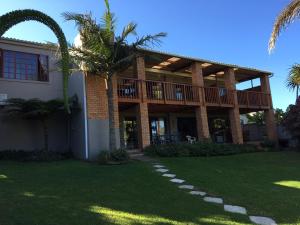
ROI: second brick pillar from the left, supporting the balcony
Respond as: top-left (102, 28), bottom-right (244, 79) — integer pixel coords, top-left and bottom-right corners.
top-left (192, 62), bottom-right (209, 140)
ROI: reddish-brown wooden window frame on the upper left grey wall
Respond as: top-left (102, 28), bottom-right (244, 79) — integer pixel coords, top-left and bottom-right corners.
top-left (0, 48), bottom-right (50, 83)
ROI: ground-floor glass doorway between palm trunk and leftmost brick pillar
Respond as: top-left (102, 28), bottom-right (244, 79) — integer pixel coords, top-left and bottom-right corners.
top-left (123, 118), bottom-right (138, 149)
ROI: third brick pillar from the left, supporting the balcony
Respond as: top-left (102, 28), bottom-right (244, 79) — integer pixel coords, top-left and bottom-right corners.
top-left (224, 68), bottom-right (243, 144)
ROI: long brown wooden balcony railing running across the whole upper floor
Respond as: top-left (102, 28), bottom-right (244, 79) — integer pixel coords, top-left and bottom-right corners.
top-left (118, 78), bottom-right (269, 108)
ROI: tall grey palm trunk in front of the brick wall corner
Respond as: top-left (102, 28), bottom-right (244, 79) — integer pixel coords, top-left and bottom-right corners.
top-left (107, 75), bottom-right (117, 151)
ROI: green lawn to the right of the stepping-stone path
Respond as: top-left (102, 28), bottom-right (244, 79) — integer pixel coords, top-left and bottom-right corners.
top-left (161, 152), bottom-right (300, 225)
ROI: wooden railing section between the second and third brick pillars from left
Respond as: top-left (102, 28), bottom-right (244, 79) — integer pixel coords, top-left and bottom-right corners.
top-left (204, 87), bottom-right (234, 105)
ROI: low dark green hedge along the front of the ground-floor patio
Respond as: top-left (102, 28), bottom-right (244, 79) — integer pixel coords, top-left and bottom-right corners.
top-left (145, 142), bottom-right (261, 157)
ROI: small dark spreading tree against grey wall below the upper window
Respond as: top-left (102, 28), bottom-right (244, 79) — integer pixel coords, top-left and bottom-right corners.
top-left (4, 98), bottom-right (72, 151)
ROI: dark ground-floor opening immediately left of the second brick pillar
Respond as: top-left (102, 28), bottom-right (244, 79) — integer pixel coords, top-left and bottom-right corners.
top-left (177, 117), bottom-right (197, 141)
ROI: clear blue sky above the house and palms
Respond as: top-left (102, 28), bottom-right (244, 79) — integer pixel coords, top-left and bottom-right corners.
top-left (0, 0), bottom-right (300, 109)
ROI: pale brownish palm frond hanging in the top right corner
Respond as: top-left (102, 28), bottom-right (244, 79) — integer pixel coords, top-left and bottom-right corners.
top-left (269, 0), bottom-right (300, 52)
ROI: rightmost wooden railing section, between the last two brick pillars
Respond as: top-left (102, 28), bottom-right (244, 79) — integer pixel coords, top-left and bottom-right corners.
top-left (237, 91), bottom-right (269, 107)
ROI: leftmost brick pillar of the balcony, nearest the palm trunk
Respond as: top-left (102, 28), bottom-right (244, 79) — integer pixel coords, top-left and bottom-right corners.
top-left (136, 57), bottom-right (150, 149)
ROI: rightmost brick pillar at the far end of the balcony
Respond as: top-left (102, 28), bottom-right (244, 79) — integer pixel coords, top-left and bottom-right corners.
top-left (260, 75), bottom-right (278, 143)
